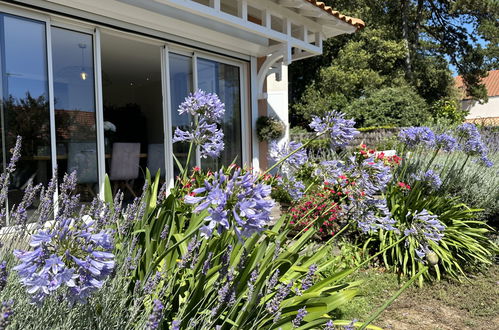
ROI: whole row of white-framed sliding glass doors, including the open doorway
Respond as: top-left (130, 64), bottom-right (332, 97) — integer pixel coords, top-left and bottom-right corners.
top-left (0, 10), bottom-right (249, 210)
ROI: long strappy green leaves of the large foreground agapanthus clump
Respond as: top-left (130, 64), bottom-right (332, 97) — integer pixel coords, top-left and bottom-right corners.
top-left (118, 172), bottom-right (364, 329)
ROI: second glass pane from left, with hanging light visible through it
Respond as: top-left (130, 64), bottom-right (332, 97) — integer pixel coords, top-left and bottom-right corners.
top-left (51, 27), bottom-right (99, 200)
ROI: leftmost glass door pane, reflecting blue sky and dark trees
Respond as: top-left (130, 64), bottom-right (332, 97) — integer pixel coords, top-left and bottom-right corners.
top-left (0, 14), bottom-right (52, 214)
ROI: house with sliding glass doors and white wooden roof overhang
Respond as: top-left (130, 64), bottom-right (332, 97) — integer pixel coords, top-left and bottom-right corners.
top-left (0, 0), bottom-right (364, 202)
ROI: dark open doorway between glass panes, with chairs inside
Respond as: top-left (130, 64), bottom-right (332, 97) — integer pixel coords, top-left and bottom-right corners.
top-left (101, 33), bottom-right (165, 197)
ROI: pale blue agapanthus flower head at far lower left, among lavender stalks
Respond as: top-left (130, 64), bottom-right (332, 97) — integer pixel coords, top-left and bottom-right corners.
top-left (13, 218), bottom-right (115, 303)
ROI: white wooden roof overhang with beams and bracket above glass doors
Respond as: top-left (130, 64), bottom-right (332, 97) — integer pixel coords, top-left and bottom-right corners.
top-left (14, 0), bottom-right (364, 97)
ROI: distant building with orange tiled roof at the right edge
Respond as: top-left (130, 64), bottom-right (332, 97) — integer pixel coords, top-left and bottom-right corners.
top-left (456, 70), bottom-right (499, 126)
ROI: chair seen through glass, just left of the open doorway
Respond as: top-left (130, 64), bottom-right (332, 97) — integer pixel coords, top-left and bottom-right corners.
top-left (68, 142), bottom-right (99, 197)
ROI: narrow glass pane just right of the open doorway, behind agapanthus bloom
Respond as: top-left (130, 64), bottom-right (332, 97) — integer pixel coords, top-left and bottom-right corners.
top-left (169, 53), bottom-right (196, 176)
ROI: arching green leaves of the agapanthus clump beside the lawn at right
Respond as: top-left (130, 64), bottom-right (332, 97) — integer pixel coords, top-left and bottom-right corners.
top-left (380, 185), bottom-right (498, 283)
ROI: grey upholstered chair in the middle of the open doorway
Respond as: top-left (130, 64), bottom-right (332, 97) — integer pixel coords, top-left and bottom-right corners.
top-left (109, 143), bottom-right (140, 197)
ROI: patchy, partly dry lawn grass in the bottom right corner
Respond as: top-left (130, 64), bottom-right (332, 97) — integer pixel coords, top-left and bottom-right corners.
top-left (328, 264), bottom-right (499, 329)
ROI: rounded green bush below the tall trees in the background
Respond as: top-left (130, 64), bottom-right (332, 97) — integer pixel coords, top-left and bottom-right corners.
top-left (345, 87), bottom-right (429, 127)
